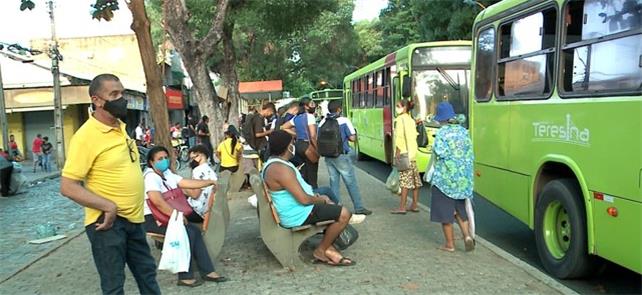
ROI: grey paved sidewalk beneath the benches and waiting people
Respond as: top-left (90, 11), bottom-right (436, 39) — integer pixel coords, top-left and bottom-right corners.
top-left (0, 165), bottom-right (559, 294)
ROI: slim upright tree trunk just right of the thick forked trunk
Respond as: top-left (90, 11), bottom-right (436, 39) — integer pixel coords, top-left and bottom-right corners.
top-left (221, 23), bottom-right (241, 127)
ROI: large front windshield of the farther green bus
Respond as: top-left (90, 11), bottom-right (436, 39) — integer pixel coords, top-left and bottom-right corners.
top-left (413, 68), bottom-right (469, 126)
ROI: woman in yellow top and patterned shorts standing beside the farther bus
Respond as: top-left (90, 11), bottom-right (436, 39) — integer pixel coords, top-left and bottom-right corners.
top-left (390, 99), bottom-right (423, 214)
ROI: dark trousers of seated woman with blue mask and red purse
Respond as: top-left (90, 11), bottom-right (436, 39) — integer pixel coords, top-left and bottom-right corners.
top-left (145, 214), bottom-right (214, 280)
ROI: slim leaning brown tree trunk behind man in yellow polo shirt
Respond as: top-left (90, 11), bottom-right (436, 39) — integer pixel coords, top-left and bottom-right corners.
top-left (128, 0), bottom-right (174, 155)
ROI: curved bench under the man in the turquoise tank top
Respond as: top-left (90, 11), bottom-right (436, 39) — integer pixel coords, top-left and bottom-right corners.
top-left (250, 169), bottom-right (334, 271)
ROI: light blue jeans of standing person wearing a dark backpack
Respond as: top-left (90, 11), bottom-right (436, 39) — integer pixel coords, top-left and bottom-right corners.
top-left (325, 152), bottom-right (364, 211)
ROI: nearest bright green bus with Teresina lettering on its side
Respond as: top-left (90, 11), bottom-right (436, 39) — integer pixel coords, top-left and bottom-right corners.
top-left (470, 0), bottom-right (642, 278)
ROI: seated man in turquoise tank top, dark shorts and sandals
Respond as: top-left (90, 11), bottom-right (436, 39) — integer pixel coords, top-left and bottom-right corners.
top-left (262, 130), bottom-right (356, 266)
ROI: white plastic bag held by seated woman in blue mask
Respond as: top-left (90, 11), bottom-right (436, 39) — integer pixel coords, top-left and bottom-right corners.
top-left (158, 210), bottom-right (191, 273)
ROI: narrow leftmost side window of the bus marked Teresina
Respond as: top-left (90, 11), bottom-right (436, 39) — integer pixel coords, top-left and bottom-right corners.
top-left (475, 27), bottom-right (495, 101)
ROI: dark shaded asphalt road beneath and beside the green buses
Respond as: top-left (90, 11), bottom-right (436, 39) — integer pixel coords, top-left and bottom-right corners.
top-left (357, 159), bottom-right (642, 294)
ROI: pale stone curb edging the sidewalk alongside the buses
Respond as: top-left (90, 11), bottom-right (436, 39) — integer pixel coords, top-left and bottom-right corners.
top-left (355, 166), bottom-right (579, 295)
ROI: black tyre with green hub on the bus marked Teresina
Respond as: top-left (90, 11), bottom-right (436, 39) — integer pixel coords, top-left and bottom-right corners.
top-left (535, 179), bottom-right (594, 279)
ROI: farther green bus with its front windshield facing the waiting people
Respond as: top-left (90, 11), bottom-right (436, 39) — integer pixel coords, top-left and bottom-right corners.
top-left (343, 41), bottom-right (471, 172)
